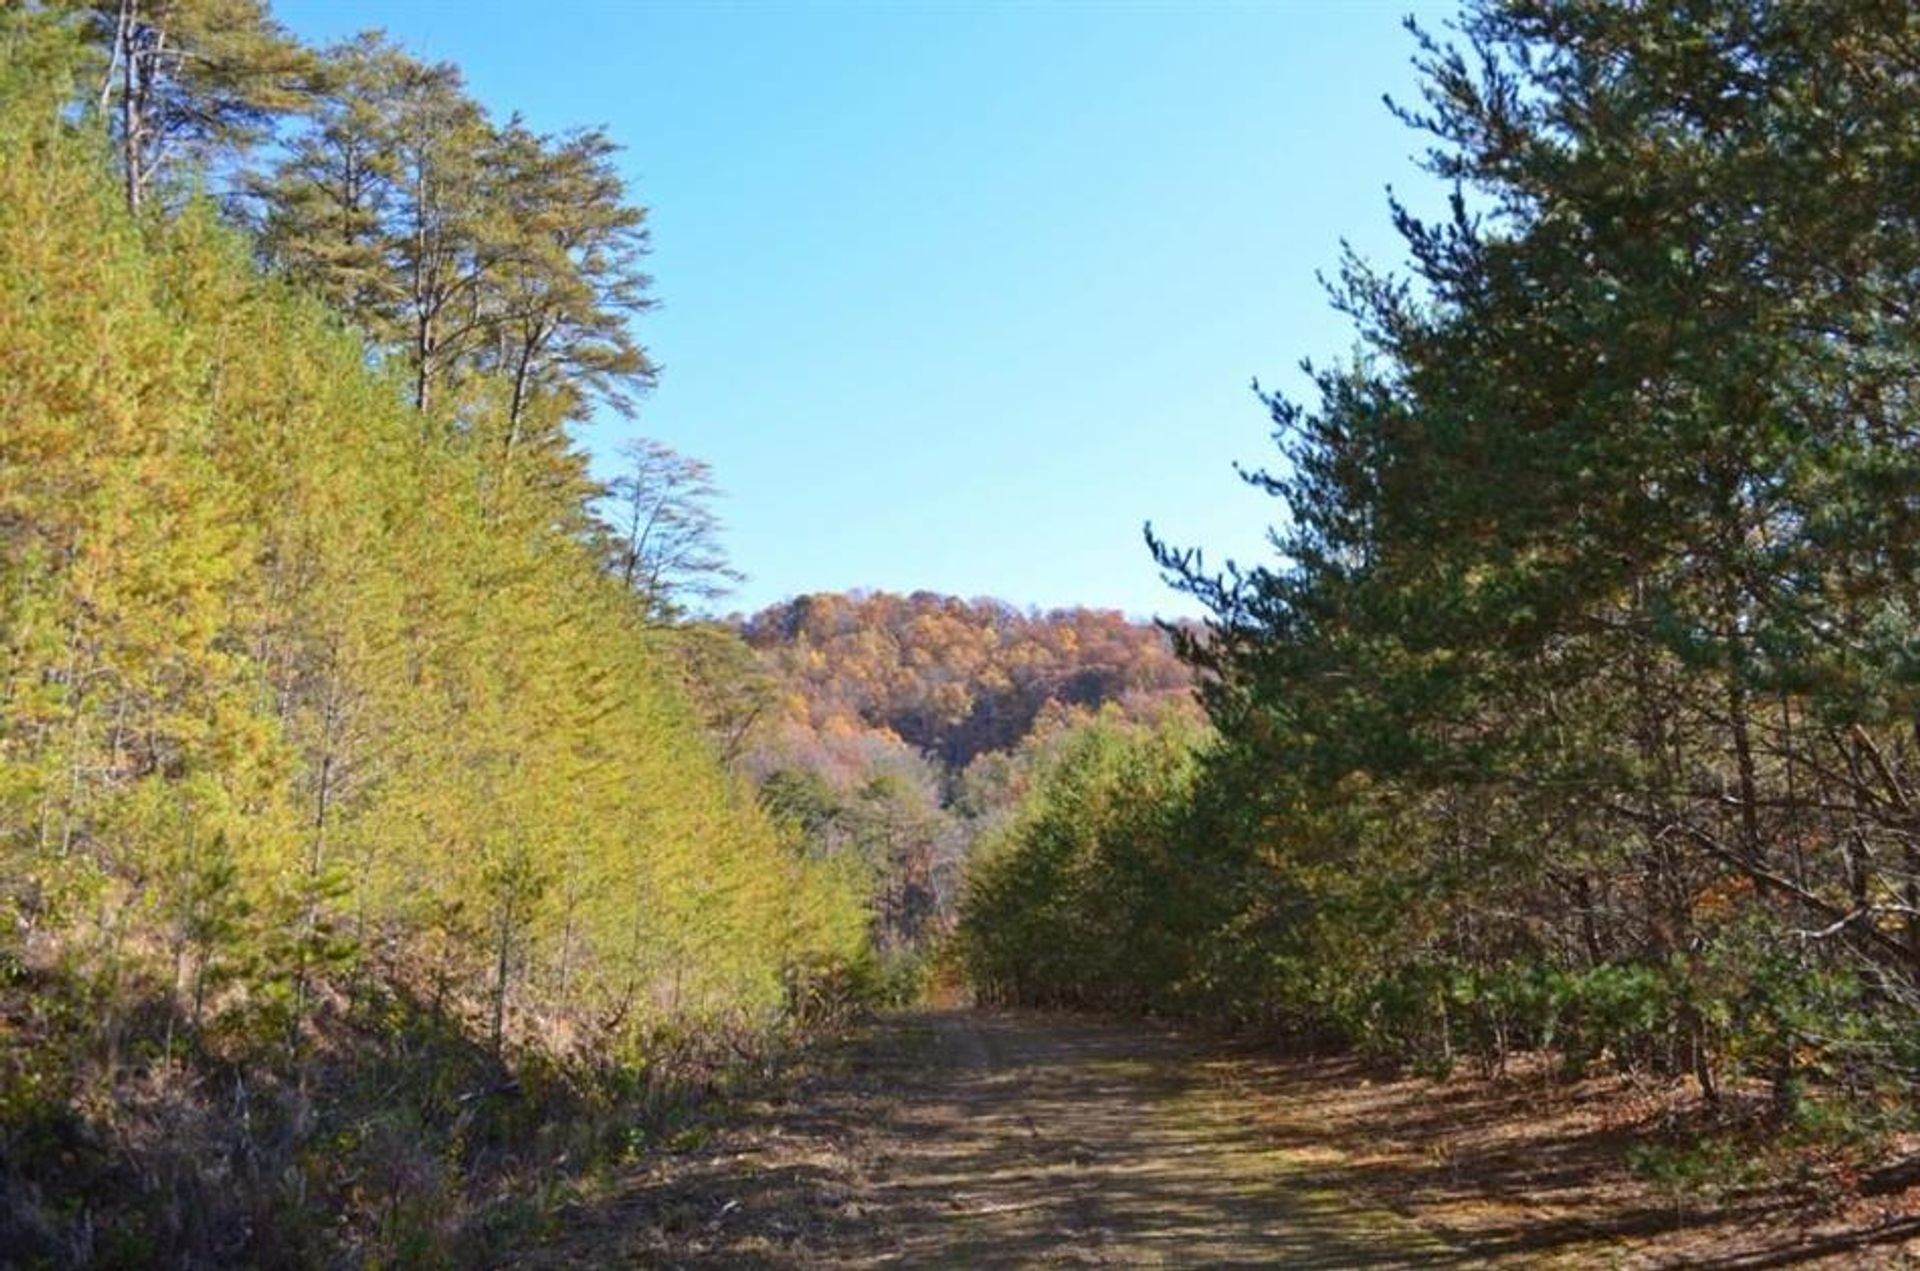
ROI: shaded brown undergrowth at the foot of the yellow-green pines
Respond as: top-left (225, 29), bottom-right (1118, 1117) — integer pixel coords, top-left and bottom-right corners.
top-left (0, 964), bottom-right (883, 1269)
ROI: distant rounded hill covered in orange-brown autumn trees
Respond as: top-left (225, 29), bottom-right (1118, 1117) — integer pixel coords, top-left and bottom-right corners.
top-left (721, 591), bottom-right (1198, 952)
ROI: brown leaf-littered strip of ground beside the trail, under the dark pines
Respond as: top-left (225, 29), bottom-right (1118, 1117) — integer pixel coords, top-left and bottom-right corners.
top-left (1206, 1048), bottom-right (1920, 1267)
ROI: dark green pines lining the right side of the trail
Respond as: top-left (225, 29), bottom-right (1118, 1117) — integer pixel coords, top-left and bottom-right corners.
top-left (962, 0), bottom-right (1920, 1137)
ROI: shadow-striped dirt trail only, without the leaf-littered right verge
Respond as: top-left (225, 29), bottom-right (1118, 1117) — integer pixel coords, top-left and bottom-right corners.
top-left (515, 1012), bottom-right (1455, 1267)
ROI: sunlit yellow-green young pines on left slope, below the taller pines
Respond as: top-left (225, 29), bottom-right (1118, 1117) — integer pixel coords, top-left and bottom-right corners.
top-left (0, 21), bottom-right (862, 1043)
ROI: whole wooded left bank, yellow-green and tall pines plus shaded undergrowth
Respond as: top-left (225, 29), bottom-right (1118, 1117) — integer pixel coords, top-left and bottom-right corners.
top-left (0, 0), bottom-right (866, 1265)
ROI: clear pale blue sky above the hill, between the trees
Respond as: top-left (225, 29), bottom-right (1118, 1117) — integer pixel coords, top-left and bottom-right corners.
top-left (275, 0), bottom-right (1452, 614)
